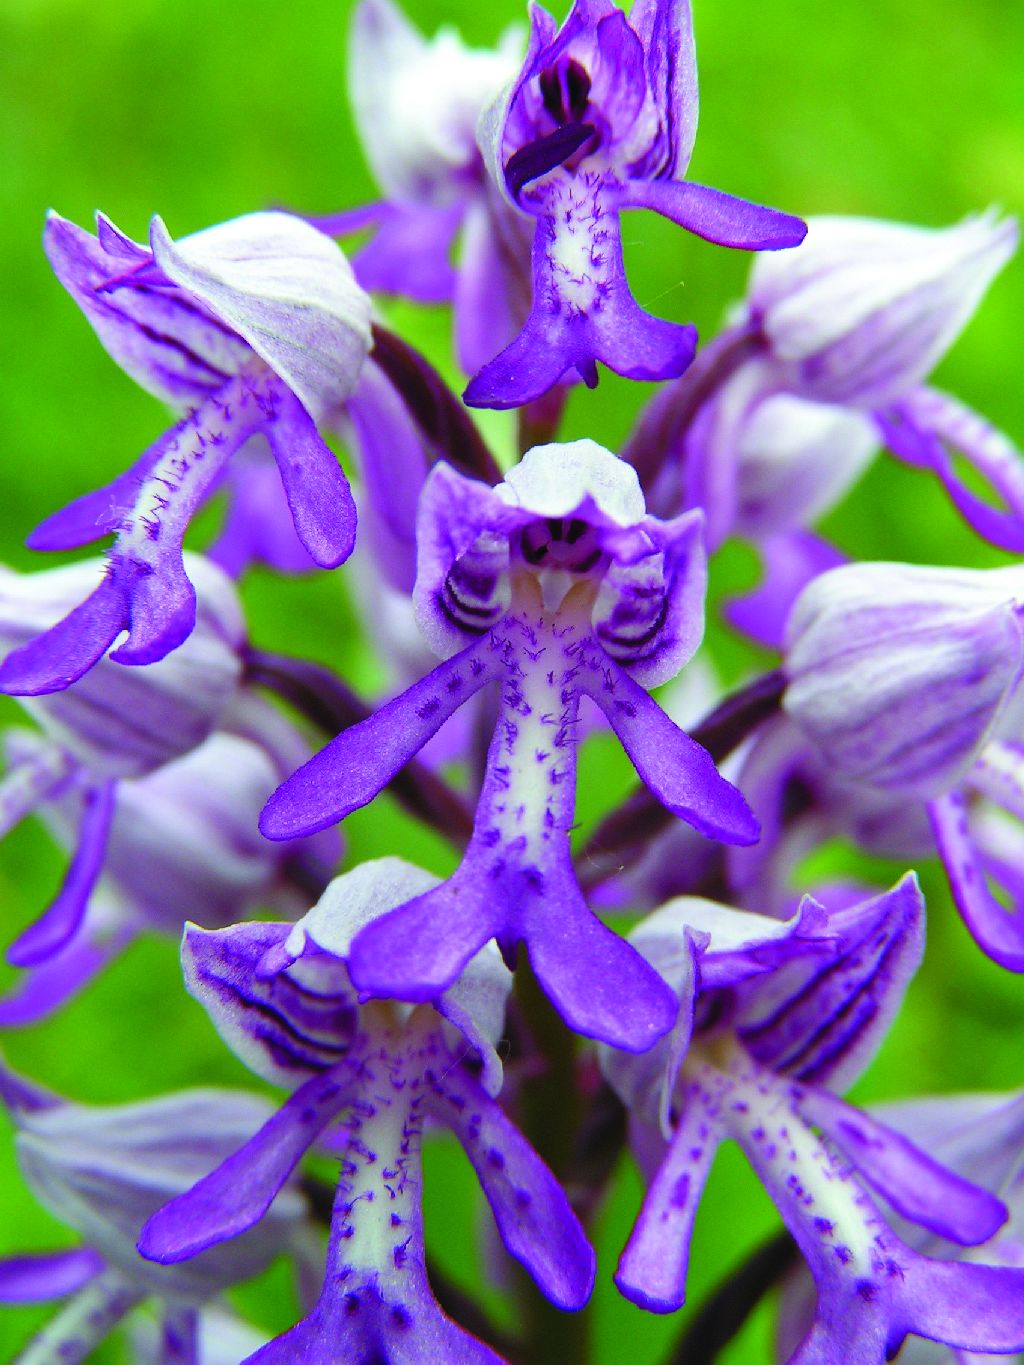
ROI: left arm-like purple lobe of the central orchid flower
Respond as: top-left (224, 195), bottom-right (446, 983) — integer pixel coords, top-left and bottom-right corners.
top-left (262, 639), bottom-right (496, 839)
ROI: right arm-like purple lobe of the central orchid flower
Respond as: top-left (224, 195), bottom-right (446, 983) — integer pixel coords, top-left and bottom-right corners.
top-left (580, 659), bottom-right (759, 844)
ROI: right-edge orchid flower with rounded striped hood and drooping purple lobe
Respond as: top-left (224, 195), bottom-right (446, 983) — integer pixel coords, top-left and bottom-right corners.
top-left (784, 564), bottom-right (1024, 972)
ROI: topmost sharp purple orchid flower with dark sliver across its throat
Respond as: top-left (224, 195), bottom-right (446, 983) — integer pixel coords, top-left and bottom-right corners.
top-left (466, 0), bottom-right (806, 408)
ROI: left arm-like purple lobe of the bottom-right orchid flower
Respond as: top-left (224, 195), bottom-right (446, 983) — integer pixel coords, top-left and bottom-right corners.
top-left (614, 1088), bottom-right (721, 1313)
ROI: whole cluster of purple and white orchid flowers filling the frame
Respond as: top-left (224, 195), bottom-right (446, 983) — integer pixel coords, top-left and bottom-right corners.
top-left (0, 0), bottom-right (1024, 1365)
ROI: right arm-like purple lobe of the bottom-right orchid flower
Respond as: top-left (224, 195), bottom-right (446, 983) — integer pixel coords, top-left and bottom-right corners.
top-left (800, 1088), bottom-right (1008, 1246)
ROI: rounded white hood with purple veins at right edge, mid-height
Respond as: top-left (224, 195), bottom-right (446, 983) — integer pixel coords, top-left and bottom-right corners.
top-left (784, 564), bottom-right (1024, 800)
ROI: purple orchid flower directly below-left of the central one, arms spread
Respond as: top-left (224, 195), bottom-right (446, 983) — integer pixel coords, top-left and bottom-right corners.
top-left (139, 857), bottom-right (594, 1365)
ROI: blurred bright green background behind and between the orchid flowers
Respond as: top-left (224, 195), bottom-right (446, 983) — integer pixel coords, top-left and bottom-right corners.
top-left (0, 0), bottom-right (1024, 1365)
